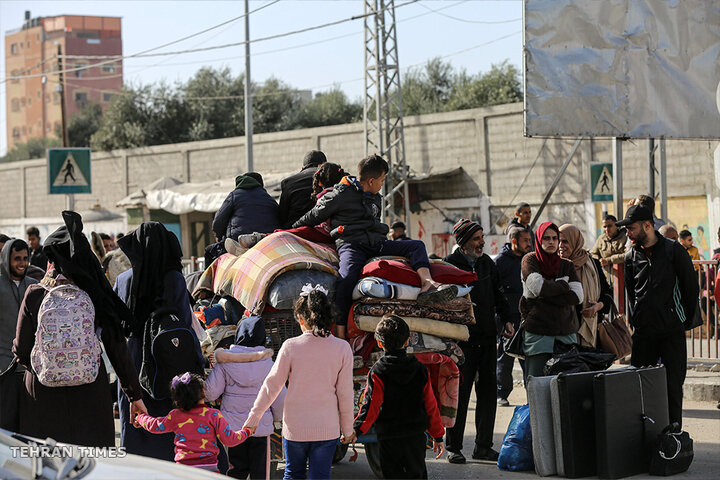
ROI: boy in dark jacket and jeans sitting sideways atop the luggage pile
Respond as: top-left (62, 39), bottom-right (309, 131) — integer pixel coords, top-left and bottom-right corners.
top-left (293, 155), bottom-right (457, 338)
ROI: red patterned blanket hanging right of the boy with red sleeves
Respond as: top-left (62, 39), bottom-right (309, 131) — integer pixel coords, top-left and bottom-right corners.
top-left (415, 353), bottom-right (460, 428)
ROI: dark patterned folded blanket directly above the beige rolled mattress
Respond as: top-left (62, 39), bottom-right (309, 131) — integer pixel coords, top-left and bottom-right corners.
top-left (353, 298), bottom-right (475, 325)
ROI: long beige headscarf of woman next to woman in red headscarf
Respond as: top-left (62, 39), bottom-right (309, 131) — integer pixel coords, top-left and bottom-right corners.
top-left (560, 223), bottom-right (600, 347)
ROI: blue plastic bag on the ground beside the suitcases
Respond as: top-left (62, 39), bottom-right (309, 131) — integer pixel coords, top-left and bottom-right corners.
top-left (498, 405), bottom-right (535, 472)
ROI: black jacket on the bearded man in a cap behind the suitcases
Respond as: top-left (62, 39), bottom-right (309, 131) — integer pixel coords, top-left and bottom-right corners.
top-left (625, 232), bottom-right (700, 337)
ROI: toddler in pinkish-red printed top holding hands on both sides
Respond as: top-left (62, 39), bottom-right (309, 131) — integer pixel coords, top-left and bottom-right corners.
top-left (136, 372), bottom-right (250, 472)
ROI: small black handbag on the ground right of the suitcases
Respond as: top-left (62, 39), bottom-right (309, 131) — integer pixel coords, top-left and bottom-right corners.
top-left (650, 422), bottom-right (695, 476)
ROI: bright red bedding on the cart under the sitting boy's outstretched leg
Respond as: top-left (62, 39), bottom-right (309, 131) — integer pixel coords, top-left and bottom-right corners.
top-left (360, 260), bottom-right (477, 287)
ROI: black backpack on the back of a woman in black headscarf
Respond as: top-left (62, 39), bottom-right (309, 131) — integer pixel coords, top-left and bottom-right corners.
top-left (139, 307), bottom-right (203, 400)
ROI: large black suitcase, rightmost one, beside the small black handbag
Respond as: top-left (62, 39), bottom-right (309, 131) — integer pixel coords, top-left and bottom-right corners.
top-left (593, 366), bottom-right (669, 478)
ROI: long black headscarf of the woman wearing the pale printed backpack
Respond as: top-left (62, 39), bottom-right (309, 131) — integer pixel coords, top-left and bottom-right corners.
top-left (43, 210), bottom-right (133, 335)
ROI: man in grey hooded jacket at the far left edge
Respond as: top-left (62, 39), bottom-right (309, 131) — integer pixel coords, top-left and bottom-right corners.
top-left (0, 239), bottom-right (37, 431)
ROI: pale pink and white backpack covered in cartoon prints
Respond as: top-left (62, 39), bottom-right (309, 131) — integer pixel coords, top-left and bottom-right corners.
top-left (30, 284), bottom-right (102, 387)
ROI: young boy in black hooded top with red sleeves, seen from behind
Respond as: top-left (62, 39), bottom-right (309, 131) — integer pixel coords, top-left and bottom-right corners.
top-left (351, 315), bottom-right (445, 478)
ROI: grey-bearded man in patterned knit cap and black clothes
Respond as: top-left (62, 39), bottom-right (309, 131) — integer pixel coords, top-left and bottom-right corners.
top-left (445, 218), bottom-right (514, 463)
